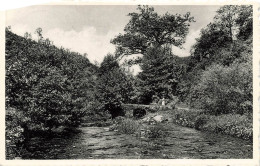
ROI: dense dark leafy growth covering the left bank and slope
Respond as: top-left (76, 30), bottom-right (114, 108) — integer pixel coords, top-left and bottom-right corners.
top-left (5, 29), bottom-right (96, 158)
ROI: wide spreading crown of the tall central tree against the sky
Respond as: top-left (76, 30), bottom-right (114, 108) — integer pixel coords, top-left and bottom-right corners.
top-left (111, 5), bottom-right (194, 55)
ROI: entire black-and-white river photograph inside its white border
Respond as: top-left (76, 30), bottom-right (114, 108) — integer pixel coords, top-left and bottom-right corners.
top-left (2, 0), bottom-right (259, 163)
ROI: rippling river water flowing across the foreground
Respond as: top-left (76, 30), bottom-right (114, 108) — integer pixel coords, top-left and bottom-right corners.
top-left (23, 123), bottom-right (253, 159)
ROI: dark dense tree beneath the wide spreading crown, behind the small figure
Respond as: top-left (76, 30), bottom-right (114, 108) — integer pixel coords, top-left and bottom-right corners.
top-left (137, 47), bottom-right (180, 104)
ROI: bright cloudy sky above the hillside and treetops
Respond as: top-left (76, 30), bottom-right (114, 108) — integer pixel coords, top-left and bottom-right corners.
top-left (6, 5), bottom-right (220, 63)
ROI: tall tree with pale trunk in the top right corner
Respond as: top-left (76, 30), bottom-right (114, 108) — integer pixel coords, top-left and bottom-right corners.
top-left (191, 5), bottom-right (253, 61)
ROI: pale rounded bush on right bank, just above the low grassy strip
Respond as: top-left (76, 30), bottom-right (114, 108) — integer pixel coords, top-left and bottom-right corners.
top-left (189, 62), bottom-right (253, 115)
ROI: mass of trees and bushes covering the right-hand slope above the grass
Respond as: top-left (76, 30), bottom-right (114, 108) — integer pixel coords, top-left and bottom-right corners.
top-left (178, 6), bottom-right (253, 115)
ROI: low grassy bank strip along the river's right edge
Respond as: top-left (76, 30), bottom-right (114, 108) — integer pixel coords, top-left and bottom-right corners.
top-left (171, 109), bottom-right (253, 140)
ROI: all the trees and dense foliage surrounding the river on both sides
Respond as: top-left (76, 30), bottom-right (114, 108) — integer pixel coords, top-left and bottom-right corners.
top-left (5, 5), bottom-right (253, 158)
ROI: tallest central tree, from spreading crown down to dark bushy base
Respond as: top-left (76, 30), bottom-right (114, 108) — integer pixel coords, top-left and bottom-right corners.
top-left (111, 5), bottom-right (194, 104)
